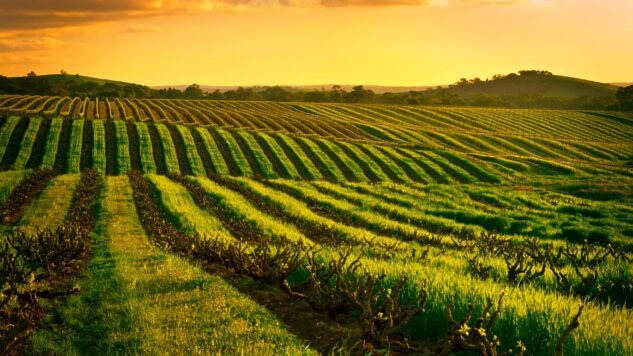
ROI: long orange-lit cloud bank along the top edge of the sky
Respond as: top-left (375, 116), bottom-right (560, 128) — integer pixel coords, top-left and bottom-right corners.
top-left (0, 0), bottom-right (553, 32)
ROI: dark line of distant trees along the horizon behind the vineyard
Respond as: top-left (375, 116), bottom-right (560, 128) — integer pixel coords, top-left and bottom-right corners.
top-left (0, 71), bottom-right (633, 111)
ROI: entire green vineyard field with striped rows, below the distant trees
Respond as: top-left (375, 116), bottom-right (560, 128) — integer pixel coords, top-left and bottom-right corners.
top-left (0, 95), bottom-right (633, 355)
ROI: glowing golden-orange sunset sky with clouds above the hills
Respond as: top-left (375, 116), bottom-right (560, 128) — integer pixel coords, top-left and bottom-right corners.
top-left (0, 0), bottom-right (633, 86)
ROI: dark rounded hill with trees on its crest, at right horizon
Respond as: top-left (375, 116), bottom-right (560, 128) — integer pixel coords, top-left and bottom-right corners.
top-left (440, 71), bottom-right (618, 99)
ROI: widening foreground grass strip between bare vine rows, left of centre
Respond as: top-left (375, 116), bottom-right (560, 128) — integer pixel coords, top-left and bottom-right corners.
top-left (30, 177), bottom-right (313, 355)
